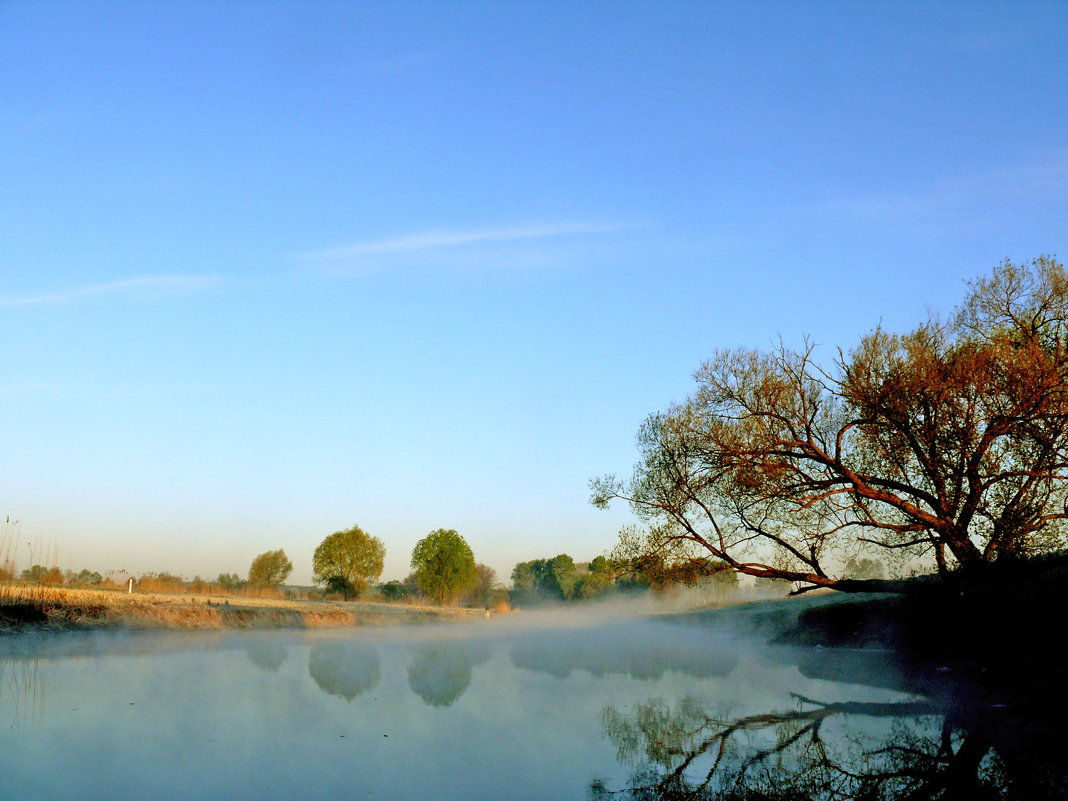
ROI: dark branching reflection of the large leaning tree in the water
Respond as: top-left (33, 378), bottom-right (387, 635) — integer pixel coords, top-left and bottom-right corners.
top-left (591, 695), bottom-right (1066, 801)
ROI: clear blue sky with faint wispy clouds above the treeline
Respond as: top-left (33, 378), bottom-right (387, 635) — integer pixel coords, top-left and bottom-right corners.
top-left (0, 0), bottom-right (1068, 581)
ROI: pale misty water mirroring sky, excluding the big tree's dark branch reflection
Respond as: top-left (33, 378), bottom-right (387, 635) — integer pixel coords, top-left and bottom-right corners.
top-left (0, 623), bottom-right (914, 799)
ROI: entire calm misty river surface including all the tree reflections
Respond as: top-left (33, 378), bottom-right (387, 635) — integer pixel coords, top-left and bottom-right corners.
top-left (0, 616), bottom-right (1050, 801)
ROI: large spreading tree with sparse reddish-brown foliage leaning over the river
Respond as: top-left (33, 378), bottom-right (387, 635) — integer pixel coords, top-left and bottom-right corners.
top-left (592, 257), bottom-right (1068, 592)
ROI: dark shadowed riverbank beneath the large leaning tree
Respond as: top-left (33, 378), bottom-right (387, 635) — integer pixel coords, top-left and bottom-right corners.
top-left (684, 554), bottom-right (1068, 714)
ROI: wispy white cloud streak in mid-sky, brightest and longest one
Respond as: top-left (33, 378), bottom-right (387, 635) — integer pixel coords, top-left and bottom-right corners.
top-left (297, 222), bottom-right (632, 262)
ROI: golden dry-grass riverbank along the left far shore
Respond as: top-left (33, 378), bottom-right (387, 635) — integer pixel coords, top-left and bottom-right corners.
top-left (0, 584), bottom-right (485, 635)
